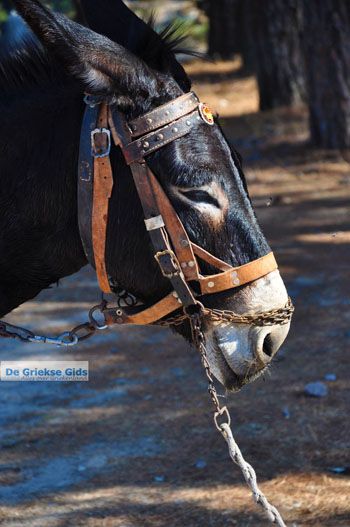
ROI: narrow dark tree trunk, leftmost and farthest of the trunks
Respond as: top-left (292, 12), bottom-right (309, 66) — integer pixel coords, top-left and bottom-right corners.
top-left (206, 0), bottom-right (239, 59)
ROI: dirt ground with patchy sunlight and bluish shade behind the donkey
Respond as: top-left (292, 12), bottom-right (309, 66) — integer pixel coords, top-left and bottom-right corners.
top-left (0, 59), bottom-right (350, 527)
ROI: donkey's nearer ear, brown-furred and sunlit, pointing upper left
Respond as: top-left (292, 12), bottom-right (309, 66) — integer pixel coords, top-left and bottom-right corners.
top-left (14, 0), bottom-right (159, 102)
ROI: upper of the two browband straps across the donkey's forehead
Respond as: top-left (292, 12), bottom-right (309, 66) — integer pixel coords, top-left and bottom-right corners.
top-left (128, 92), bottom-right (199, 137)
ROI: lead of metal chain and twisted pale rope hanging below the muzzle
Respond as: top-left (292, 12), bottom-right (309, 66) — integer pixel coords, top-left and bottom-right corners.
top-left (190, 313), bottom-right (286, 527)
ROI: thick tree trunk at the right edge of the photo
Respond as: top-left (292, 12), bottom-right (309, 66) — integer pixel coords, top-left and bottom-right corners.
top-left (304, 0), bottom-right (350, 149)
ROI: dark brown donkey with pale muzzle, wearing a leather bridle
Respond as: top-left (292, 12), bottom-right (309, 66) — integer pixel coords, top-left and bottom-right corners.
top-left (0, 0), bottom-right (289, 390)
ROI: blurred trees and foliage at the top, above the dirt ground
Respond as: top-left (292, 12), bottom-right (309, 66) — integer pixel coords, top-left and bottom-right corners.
top-left (0, 0), bottom-right (350, 149)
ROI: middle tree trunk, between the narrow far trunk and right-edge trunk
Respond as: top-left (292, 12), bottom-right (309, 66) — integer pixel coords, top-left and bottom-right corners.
top-left (250, 0), bottom-right (304, 110)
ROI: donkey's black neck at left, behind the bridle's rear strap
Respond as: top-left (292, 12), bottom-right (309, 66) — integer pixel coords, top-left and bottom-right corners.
top-left (0, 89), bottom-right (86, 316)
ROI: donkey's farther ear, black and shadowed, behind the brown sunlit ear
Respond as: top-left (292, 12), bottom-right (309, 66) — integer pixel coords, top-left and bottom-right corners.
top-left (80, 0), bottom-right (191, 92)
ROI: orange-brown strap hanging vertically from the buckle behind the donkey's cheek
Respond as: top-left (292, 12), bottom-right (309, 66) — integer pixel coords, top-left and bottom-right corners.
top-left (92, 104), bottom-right (113, 293)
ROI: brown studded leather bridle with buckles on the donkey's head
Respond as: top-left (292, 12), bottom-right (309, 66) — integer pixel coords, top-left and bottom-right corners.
top-left (78, 92), bottom-right (292, 325)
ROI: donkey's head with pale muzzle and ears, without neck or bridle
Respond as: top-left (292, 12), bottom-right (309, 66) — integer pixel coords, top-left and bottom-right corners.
top-left (14, 0), bottom-right (289, 389)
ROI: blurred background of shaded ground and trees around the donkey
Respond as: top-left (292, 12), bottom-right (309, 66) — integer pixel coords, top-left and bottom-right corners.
top-left (0, 0), bottom-right (350, 527)
